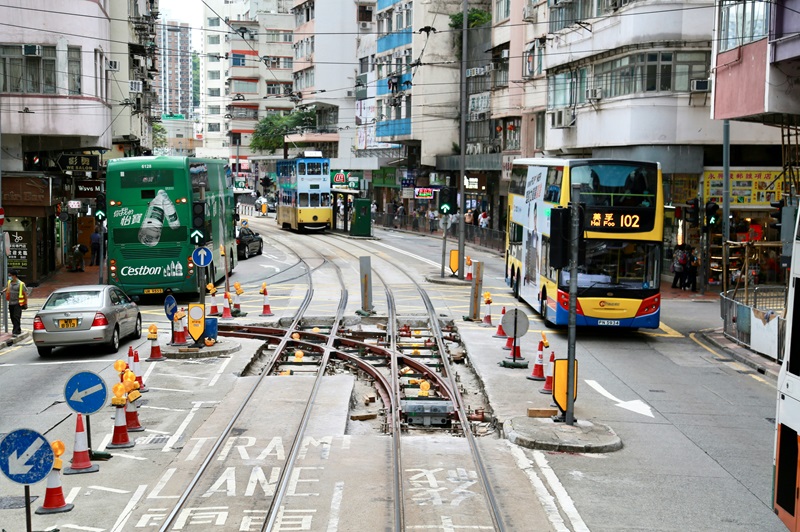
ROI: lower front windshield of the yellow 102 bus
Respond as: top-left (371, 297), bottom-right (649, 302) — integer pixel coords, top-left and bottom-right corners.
top-left (559, 240), bottom-right (660, 289)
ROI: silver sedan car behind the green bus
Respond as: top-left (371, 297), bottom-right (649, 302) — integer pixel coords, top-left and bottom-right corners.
top-left (33, 285), bottom-right (142, 356)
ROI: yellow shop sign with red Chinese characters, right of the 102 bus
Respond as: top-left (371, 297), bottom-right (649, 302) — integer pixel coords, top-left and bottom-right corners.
top-left (703, 170), bottom-right (784, 207)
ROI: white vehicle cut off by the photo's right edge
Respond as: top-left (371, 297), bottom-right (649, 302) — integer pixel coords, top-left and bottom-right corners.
top-left (772, 209), bottom-right (800, 530)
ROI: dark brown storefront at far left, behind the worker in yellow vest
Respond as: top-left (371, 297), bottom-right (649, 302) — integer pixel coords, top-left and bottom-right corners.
top-left (3, 173), bottom-right (66, 284)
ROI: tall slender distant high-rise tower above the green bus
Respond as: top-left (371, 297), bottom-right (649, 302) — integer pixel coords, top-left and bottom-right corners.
top-left (155, 20), bottom-right (194, 117)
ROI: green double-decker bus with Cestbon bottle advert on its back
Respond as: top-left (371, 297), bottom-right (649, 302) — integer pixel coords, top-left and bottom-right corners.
top-left (106, 157), bottom-right (236, 294)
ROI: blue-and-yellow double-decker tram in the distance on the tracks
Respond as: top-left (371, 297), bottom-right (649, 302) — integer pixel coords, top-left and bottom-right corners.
top-left (276, 151), bottom-right (332, 231)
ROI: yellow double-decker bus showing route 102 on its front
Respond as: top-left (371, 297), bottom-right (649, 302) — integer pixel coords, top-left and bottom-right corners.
top-left (505, 158), bottom-right (664, 329)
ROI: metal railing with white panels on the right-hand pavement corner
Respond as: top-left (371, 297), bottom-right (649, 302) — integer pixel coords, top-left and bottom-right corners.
top-left (719, 285), bottom-right (787, 363)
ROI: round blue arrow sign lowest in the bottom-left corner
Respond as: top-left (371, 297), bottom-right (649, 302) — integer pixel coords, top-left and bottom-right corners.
top-left (0, 429), bottom-right (55, 484)
